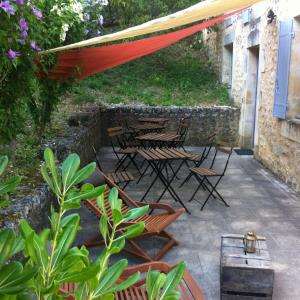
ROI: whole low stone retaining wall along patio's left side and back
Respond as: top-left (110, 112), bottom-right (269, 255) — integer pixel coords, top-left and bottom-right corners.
top-left (0, 105), bottom-right (239, 229)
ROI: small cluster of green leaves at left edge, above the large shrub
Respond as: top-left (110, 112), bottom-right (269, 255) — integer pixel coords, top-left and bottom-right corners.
top-left (0, 156), bottom-right (22, 208)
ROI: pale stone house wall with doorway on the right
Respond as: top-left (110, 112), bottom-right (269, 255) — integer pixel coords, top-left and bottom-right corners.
top-left (203, 0), bottom-right (300, 191)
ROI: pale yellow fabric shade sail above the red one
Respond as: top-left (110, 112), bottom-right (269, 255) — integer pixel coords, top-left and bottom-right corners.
top-left (41, 0), bottom-right (262, 53)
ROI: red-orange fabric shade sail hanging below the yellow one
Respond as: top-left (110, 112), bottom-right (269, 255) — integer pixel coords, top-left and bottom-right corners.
top-left (49, 10), bottom-right (241, 80)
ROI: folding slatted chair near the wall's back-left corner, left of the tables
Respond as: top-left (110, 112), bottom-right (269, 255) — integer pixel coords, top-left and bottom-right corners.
top-left (107, 126), bottom-right (141, 175)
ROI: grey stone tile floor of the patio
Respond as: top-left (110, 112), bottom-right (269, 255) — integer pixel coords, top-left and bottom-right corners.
top-left (78, 147), bottom-right (300, 300)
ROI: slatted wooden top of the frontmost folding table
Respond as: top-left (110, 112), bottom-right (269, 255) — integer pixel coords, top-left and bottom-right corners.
top-left (138, 148), bottom-right (191, 160)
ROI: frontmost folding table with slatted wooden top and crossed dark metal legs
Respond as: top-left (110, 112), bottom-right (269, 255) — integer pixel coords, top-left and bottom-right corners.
top-left (138, 148), bottom-right (191, 213)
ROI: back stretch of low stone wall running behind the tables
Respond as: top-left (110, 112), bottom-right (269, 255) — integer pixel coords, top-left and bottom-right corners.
top-left (101, 105), bottom-right (239, 146)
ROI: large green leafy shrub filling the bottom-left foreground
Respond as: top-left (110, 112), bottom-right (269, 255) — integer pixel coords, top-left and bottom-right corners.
top-left (0, 148), bottom-right (185, 300)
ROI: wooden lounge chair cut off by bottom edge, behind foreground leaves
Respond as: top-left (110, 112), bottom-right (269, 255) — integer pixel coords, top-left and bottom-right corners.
top-left (60, 261), bottom-right (204, 300)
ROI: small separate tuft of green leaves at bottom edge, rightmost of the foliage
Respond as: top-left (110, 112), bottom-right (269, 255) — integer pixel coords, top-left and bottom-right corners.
top-left (146, 262), bottom-right (186, 300)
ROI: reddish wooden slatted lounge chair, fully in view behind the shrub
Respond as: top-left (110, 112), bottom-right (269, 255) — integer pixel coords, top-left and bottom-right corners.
top-left (84, 175), bottom-right (185, 261)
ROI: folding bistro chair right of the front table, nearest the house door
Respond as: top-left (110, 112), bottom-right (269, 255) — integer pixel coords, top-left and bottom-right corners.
top-left (189, 147), bottom-right (232, 210)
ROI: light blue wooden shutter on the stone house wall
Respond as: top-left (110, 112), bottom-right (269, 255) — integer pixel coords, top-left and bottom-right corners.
top-left (273, 20), bottom-right (293, 119)
